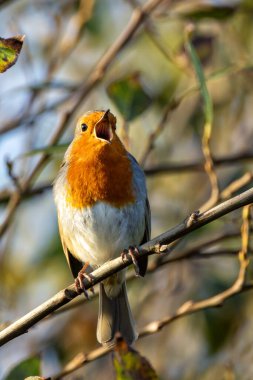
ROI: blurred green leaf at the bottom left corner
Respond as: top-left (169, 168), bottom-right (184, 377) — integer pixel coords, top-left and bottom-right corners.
top-left (5, 356), bottom-right (40, 380)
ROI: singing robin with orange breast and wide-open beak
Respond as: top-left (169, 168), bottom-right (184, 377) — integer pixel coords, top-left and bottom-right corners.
top-left (53, 109), bottom-right (151, 346)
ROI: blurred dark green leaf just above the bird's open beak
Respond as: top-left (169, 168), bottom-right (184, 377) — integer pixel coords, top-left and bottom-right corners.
top-left (107, 73), bottom-right (152, 121)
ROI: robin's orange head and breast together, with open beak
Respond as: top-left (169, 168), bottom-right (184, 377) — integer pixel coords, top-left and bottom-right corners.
top-left (64, 110), bottom-right (135, 207)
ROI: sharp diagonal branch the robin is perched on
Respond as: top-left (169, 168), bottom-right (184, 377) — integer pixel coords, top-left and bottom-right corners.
top-left (0, 188), bottom-right (253, 346)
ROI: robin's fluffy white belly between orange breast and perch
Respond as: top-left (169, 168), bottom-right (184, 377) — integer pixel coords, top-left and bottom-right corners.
top-left (58, 198), bottom-right (145, 267)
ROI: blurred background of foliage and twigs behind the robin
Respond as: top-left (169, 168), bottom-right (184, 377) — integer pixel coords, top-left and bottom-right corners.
top-left (0, 0), bottom-right (253, 380)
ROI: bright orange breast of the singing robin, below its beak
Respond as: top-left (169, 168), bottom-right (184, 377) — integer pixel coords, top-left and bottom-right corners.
top-left (67, 137), bottom-right (135, 208)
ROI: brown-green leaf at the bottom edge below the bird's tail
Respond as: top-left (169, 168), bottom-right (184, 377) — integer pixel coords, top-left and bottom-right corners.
top-left (113, 336), bottom-right (158, 380)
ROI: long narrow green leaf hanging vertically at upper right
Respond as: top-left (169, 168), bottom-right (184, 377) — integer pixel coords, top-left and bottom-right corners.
top-left (186, 34), bottom-right (213, 125)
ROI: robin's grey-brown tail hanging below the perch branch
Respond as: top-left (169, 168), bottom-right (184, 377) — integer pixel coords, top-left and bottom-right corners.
top-left (97, 281), bottom-right (138, 346)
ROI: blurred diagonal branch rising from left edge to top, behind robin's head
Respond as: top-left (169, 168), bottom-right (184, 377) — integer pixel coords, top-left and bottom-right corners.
top-left (0, 0), bottom-right (163, 236)
